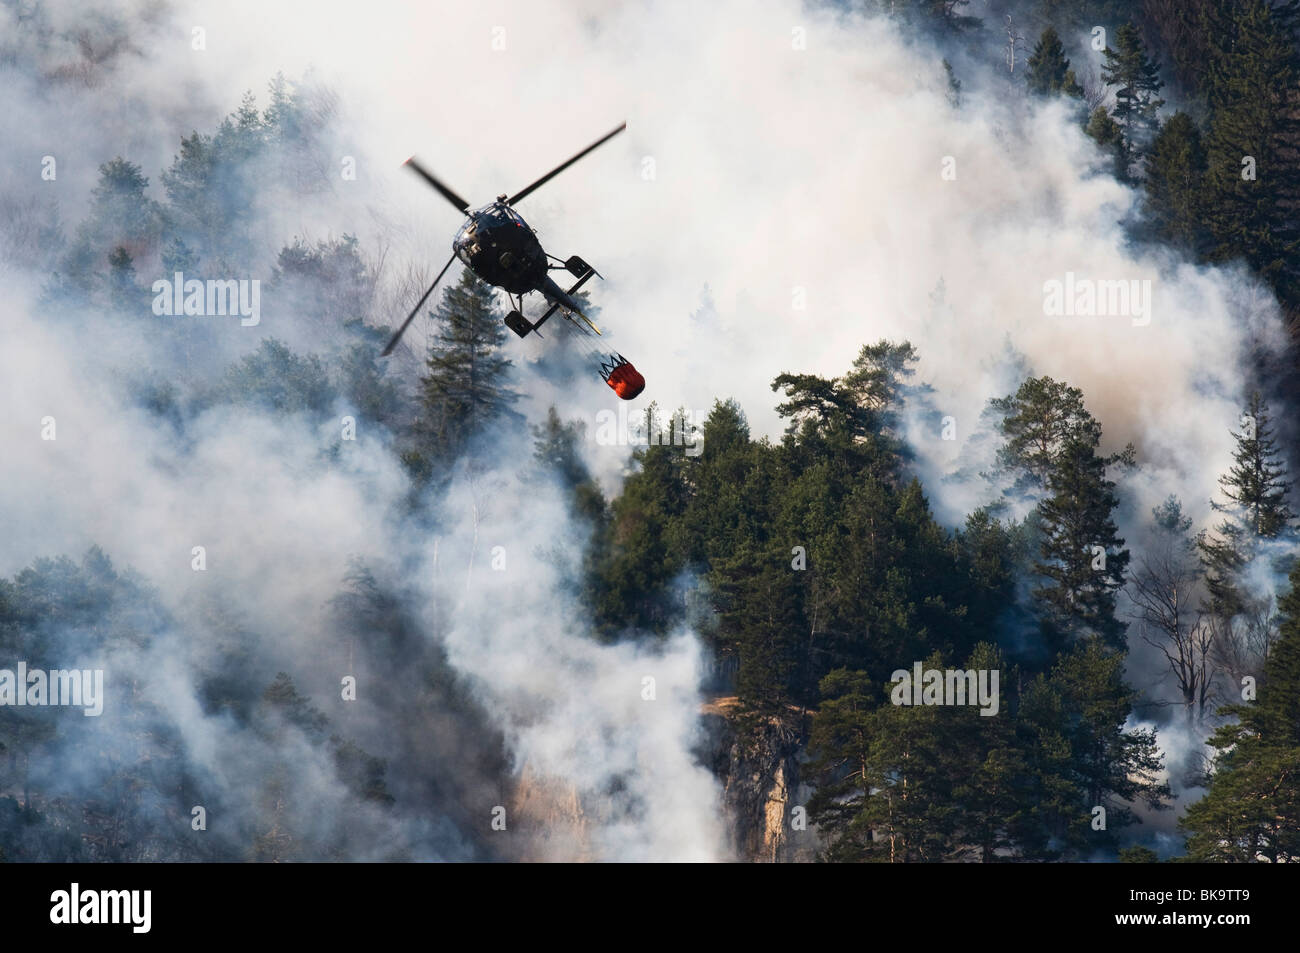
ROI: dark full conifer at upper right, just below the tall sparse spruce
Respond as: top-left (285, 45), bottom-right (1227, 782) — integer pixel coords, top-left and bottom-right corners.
top-left (1144, 112), bottom-right (1205, 251)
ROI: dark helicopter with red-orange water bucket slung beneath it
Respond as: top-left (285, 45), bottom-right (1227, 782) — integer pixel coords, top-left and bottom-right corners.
top-left (381, 122), bottom-right (646, 400)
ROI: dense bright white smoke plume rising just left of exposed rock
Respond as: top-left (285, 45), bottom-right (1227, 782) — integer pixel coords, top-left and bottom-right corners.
top-left (431, 460), bottom-right (724, 861)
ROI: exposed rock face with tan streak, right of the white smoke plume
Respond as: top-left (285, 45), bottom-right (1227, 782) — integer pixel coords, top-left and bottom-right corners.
top-left (699, 697), bottom-right (818, 863)
